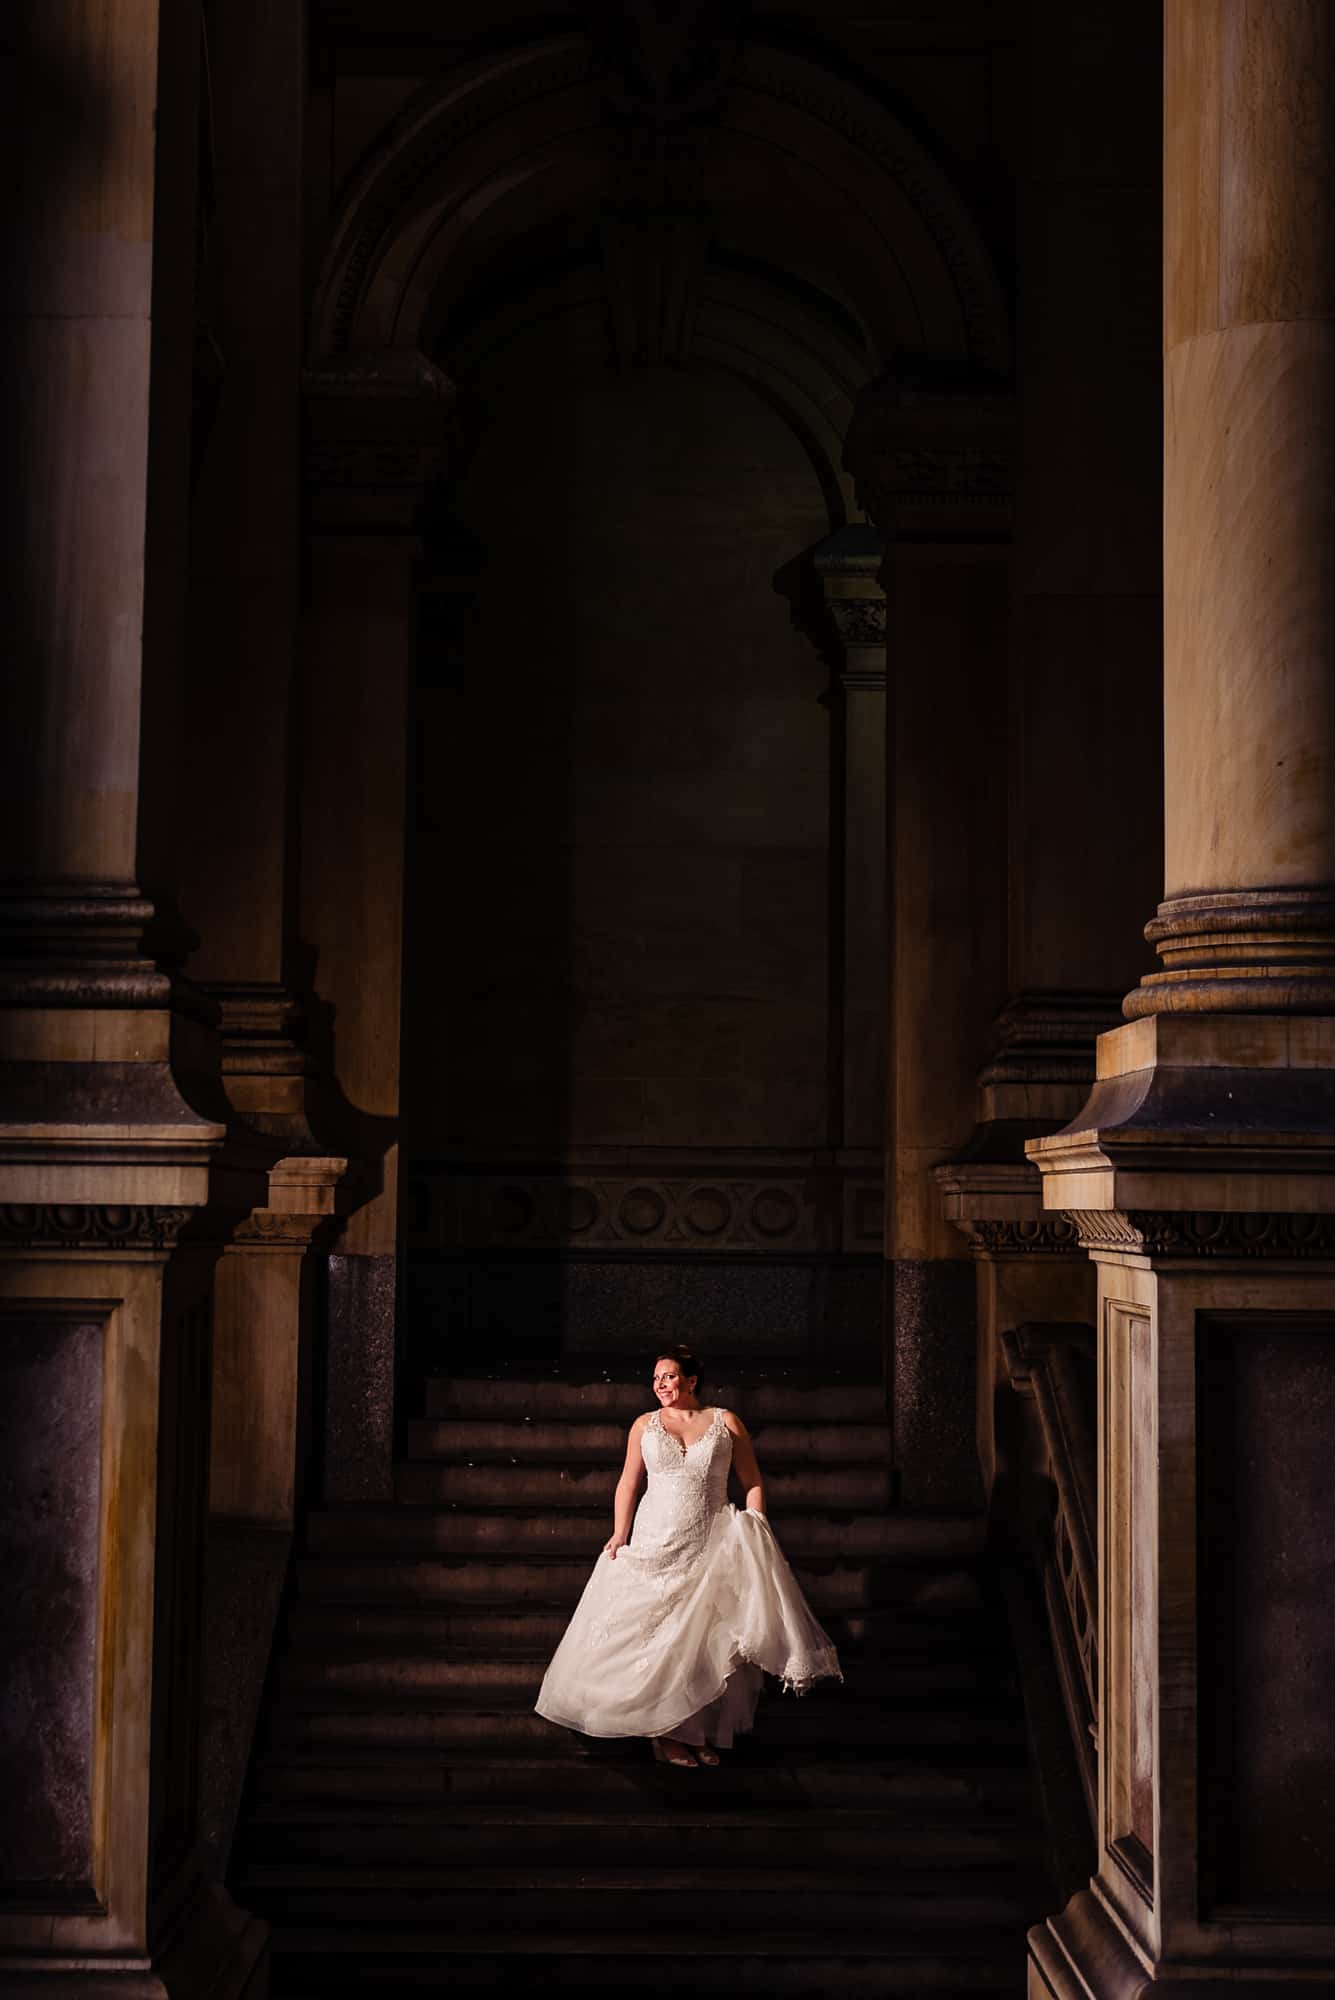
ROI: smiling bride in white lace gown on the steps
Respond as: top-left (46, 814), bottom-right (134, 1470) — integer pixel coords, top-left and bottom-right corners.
top-left (536, 1348), bottom-right (843, 1768)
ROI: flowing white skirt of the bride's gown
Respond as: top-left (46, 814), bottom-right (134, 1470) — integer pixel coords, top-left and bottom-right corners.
top-left (536, 1502), bottom-right (841, 1746)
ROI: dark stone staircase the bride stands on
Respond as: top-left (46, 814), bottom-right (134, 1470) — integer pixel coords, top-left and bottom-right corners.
top-left (234, 1364), bottom-right (1053, 1996)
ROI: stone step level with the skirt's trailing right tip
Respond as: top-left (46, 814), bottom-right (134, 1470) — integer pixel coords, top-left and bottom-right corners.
top-left (280, 1640), bottom-right (1005, 1706)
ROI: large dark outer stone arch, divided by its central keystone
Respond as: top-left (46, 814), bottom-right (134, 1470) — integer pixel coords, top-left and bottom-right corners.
top-left (312, 34), bottom-right (1009, 380)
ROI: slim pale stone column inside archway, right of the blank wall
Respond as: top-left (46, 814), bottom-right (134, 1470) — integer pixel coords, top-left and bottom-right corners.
top-left (813, 526), bottom-right (885, 1252)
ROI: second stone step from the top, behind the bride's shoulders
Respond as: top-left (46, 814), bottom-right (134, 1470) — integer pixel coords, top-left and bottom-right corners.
top-left (408, 1416), bottom-right (891, 1470)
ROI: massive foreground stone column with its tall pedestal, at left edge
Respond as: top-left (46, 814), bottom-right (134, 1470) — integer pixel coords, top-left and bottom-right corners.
top-left (0, 0), bottom-right (266, 1996)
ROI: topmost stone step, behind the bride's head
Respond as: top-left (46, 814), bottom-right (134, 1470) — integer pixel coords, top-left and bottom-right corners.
top-left (426, 1356), bottom-right (885, 1430)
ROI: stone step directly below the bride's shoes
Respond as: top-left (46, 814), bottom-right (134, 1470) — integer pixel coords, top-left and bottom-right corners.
top-left (256, 1738), bottom-right (1031, 1824)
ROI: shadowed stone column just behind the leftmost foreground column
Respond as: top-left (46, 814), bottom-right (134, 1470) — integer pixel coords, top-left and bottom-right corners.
top-left (166, 0), bottom-right (346, 1874)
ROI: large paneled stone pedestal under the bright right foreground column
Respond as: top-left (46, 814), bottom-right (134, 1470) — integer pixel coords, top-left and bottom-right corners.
top-left (1029, 1016), bottom-right (1335, 2000)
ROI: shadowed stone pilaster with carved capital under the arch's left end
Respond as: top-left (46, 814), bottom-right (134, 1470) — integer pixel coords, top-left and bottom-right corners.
top-left (300, 352), bottom-right (454, 1500)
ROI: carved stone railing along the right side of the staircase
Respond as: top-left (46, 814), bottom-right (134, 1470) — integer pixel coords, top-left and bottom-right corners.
top-left (1001, 1324), bottom-right (1099, 1822)
